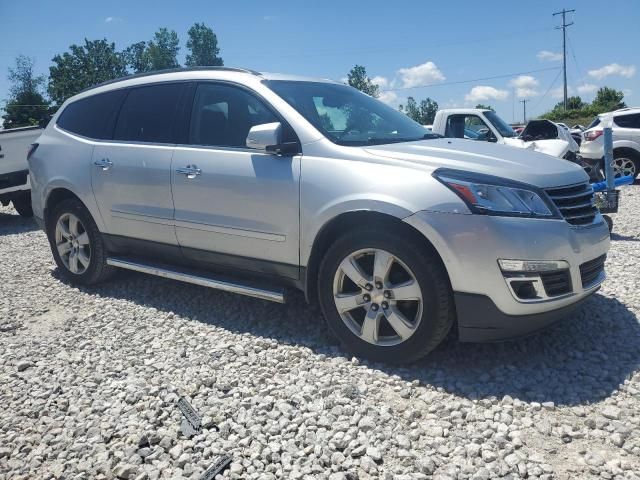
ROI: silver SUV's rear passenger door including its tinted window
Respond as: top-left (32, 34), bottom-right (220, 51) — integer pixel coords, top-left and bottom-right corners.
top-left (92, 82), bottom-right (188, 245)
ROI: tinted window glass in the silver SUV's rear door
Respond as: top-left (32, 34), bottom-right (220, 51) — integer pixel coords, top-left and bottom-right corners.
top-left (113, 83), bottom-right (185, 143)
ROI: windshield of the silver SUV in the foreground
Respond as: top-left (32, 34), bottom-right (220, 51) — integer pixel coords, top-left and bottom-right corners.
top-left (264, 80), bottom-right (440, 146)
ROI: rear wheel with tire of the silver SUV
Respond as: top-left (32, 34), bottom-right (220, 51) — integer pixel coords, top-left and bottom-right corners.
top-left (47, 199), bottom-right (115, 285)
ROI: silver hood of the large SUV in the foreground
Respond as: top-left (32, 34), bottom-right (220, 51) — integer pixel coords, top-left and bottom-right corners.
top-left (365, 138), bottom-right (589, 188)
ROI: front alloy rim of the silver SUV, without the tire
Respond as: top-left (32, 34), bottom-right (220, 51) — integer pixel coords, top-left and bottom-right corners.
top-left (333, 248), bottom-right (423, 346)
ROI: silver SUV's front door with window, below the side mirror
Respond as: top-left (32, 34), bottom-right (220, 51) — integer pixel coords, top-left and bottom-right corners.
top-left (171, 82), bottom-right (300, 277)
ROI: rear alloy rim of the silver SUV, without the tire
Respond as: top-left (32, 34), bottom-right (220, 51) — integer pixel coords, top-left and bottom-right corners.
top-left (55, 213), bottom-right (91, 275)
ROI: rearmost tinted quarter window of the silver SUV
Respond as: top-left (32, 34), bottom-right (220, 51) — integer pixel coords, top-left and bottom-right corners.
top-left (56, 90), bottom-right (126, 140)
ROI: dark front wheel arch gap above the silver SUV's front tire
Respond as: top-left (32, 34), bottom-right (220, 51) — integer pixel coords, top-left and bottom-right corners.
top-left (303, 210), bottom-right (447, 304)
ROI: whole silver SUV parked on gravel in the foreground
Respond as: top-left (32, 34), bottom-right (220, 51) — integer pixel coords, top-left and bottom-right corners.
top-left (29, 68), bottom-right (609, 362)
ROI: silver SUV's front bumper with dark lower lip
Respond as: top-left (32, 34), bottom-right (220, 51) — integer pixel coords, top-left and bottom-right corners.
top-left (404, 211), bottom-right (609, 340)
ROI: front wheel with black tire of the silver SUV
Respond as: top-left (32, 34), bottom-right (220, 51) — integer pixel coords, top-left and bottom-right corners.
top-left (318, 227), bottom-right (455, 363)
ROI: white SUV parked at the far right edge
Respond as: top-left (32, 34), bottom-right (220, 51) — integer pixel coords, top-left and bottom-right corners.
top-left (580, 108), bottom-right (640, 178)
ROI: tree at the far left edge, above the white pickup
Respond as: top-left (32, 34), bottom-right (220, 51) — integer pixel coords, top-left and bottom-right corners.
top-left (2, 55), bottom-right (49, 128)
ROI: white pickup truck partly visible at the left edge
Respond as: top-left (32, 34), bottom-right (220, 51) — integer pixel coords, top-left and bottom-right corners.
top-left (0, 127), bottom-right (43, 217)
